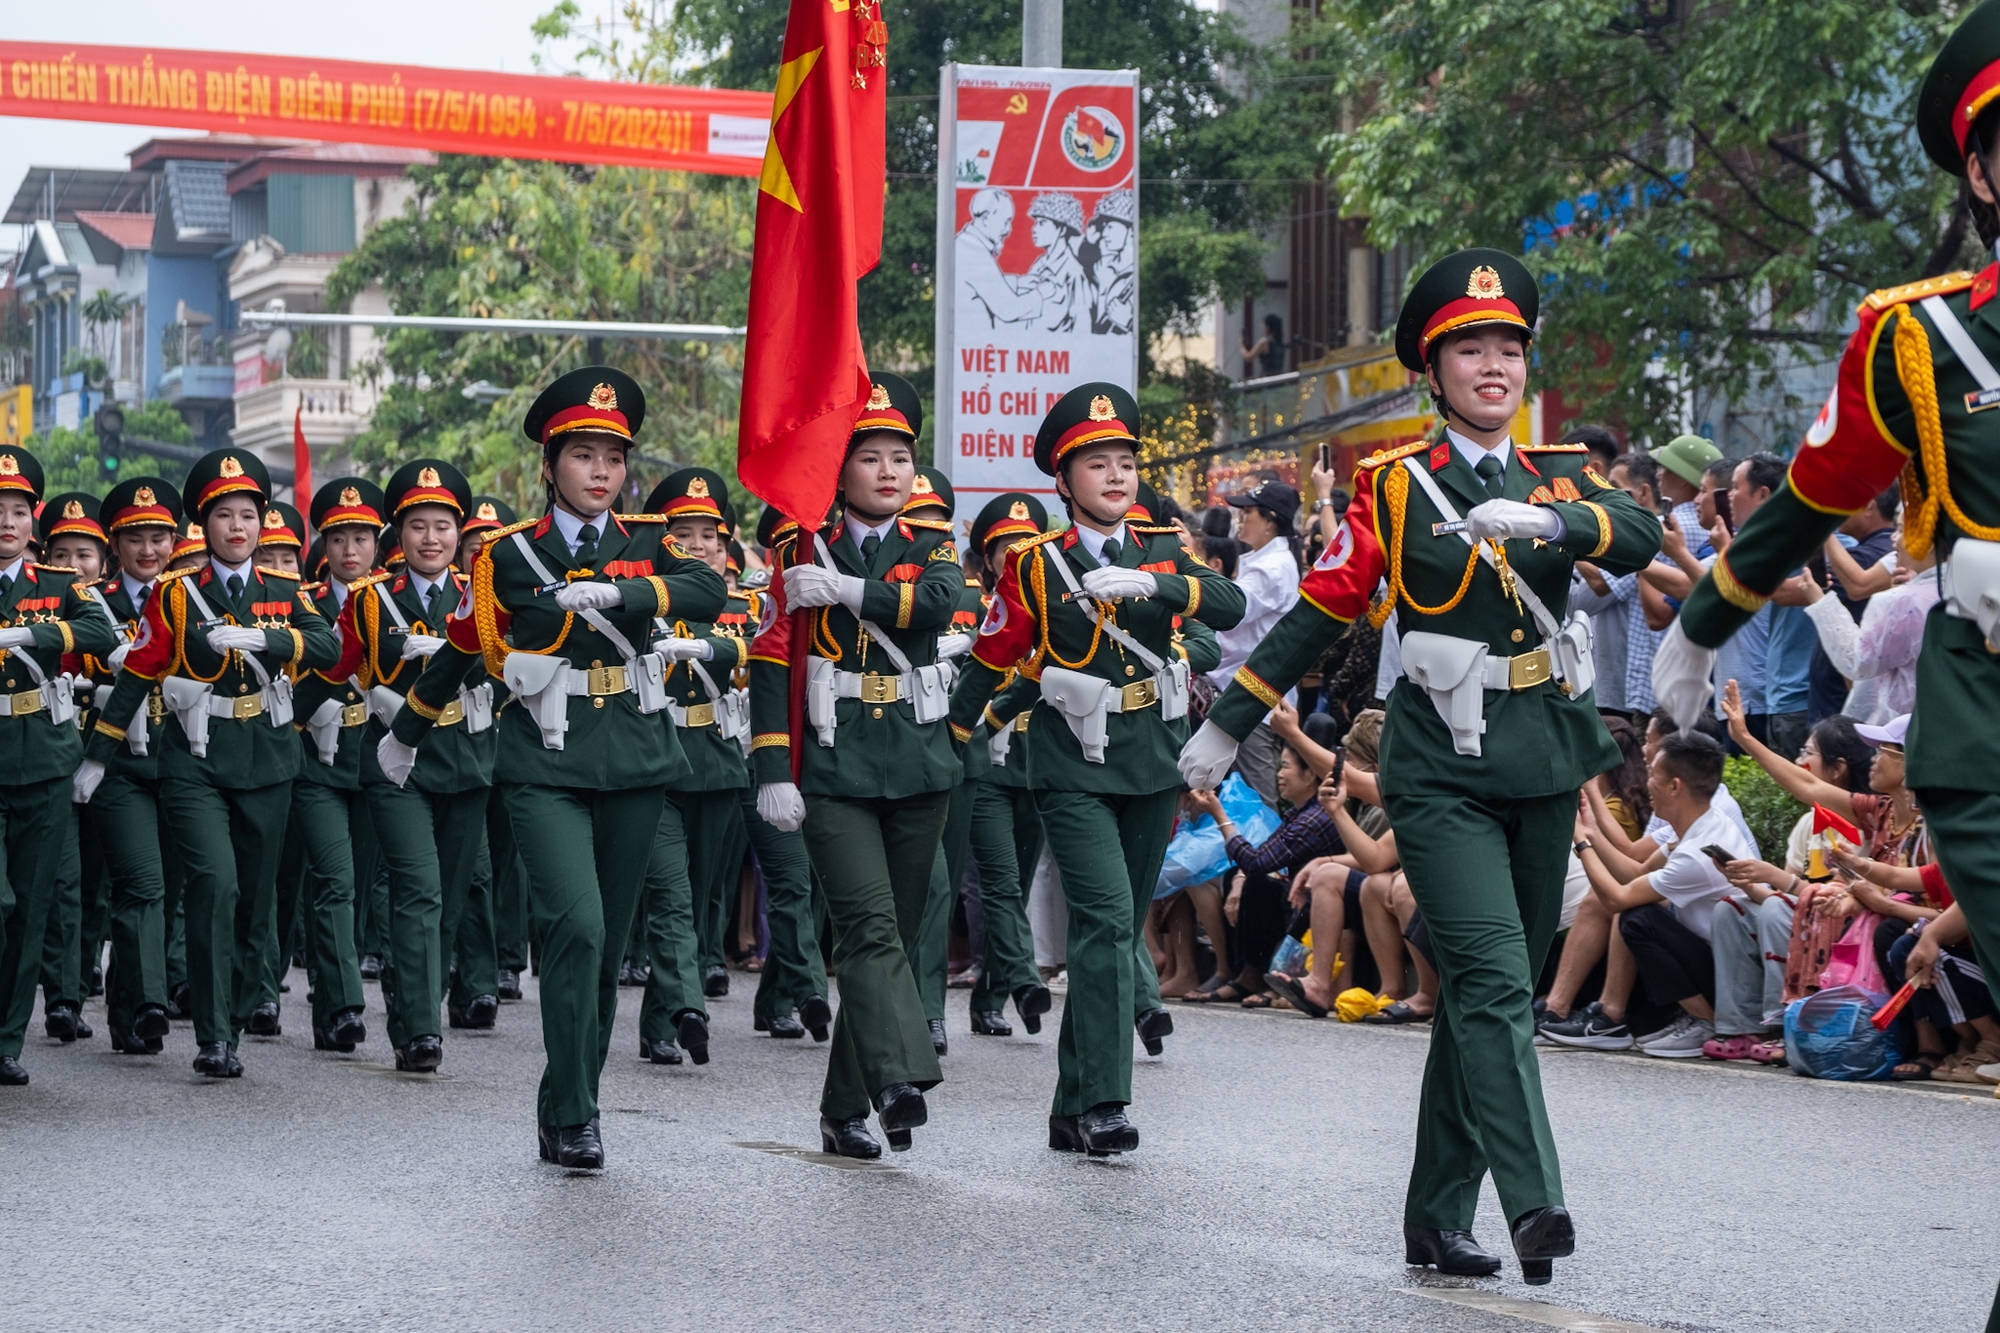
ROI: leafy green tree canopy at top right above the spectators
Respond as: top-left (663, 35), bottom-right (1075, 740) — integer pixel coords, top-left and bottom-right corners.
top-left (1312, 0), bottom-right (1968, 434)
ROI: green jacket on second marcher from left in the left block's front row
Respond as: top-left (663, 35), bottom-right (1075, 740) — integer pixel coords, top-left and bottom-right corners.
top-left (88, 564), bottom-right (340, 789)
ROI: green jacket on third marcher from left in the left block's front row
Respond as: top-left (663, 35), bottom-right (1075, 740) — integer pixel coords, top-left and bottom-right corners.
top-left (336, 572), bottom-right (506, 795)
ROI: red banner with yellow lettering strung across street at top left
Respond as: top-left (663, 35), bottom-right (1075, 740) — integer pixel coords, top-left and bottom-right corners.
top-left (0, 42), bottom-right (770, 176)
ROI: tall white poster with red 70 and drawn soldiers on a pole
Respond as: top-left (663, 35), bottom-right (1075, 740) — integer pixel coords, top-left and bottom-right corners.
top-left (934, 64), bottom-right (1138, 526)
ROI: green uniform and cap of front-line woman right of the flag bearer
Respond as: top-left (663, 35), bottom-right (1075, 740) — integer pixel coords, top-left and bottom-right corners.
top-left (952, 384), bottom-right (1244, 1153)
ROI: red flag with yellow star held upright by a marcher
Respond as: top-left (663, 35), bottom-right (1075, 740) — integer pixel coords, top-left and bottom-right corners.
top-left (736, 0), bottom-right (888, 532)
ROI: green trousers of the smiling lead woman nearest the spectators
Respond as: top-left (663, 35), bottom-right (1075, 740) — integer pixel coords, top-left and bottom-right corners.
top-left (1384, 793), bottom-right (1576, 1231)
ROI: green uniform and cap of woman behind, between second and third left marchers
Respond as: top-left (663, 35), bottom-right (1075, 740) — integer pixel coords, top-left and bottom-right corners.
top-left (280, 476), bottom-right (388, 1051)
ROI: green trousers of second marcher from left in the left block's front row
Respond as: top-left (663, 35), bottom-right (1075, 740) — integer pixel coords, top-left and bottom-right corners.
top-left (160, 779), bottom-right (292, 1047)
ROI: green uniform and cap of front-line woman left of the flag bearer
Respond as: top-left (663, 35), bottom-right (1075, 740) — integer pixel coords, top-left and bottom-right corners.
top-left (384, 366), bottom-right (726, 1167)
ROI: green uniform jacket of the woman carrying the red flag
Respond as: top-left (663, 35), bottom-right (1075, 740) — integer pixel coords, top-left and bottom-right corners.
top-left (750, 518), bottom-right (966, 799)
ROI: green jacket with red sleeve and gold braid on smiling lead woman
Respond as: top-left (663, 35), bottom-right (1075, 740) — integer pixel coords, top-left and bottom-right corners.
top-left (1208, 440), bottom-right (1660, 797)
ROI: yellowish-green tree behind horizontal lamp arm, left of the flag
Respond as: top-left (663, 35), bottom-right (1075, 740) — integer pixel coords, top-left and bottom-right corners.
top-left (328, 158), bottom-right (754, 512)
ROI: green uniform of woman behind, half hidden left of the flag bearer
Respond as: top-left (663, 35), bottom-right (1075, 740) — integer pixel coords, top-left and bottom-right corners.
top-left (638, 468), bottom-right (752, 1065)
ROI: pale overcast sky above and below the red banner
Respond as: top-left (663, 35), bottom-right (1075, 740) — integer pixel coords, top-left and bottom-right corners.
top-left (0, 0), bottom-right (614, 241)
